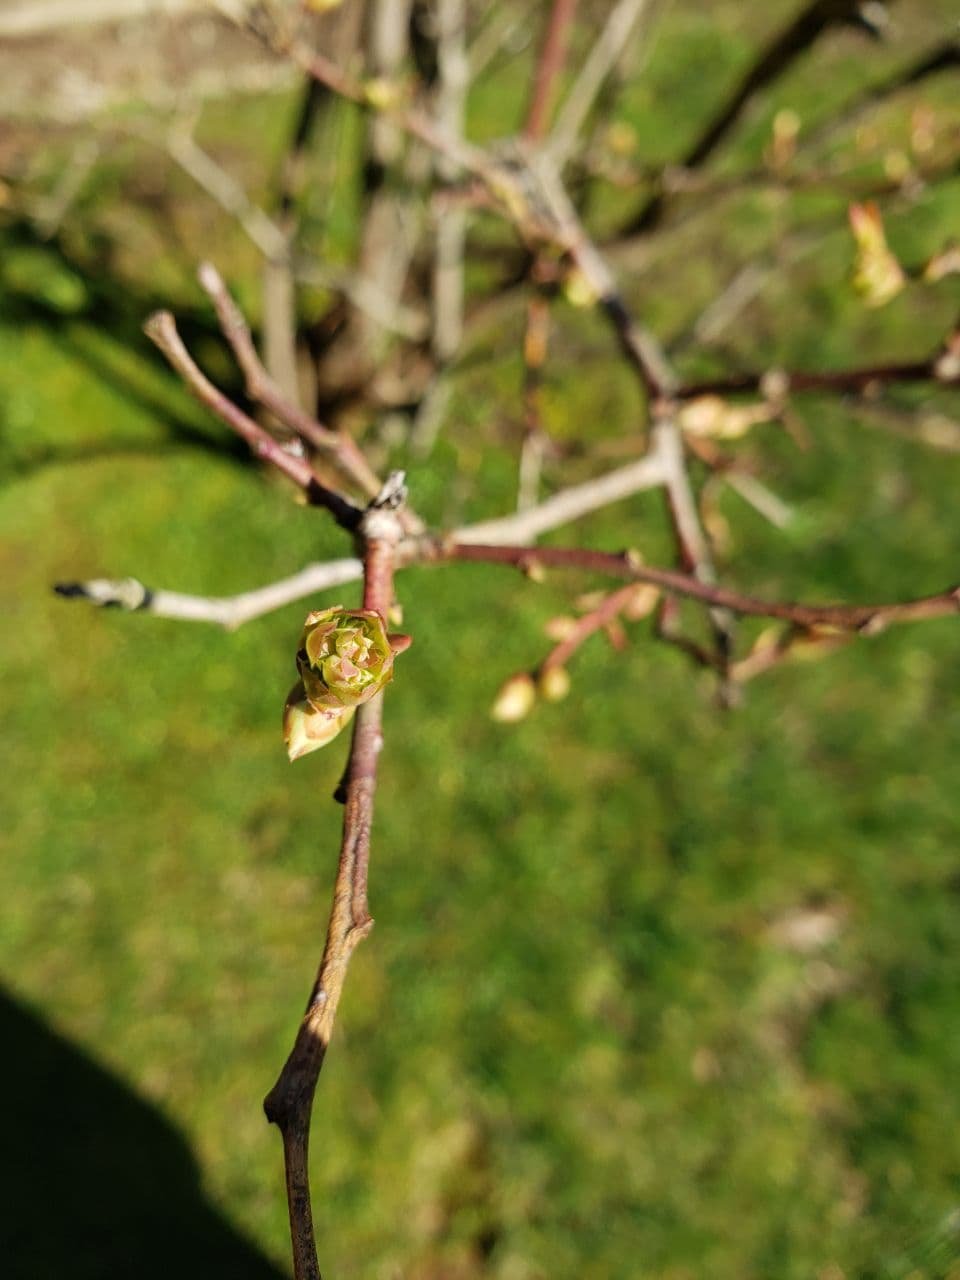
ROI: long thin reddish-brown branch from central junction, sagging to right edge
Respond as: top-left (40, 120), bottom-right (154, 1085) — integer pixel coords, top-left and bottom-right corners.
top-left (450, 543), bottom-right (960, 634)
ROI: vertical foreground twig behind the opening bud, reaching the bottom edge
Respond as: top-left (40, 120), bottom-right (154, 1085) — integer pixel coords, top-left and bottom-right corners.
top-left (264, 481), bottom-right (403, 1280)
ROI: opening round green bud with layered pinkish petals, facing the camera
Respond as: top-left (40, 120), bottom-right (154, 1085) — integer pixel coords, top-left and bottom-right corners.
top-left (297, 604), bottom-right (394, 712)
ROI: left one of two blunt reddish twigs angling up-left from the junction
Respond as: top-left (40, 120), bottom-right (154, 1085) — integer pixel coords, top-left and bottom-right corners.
top-left (143, 311), bottom-right (360, 529)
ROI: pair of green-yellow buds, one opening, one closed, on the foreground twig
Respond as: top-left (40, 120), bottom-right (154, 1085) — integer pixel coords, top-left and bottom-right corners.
top-left (283, 604), bottom-right (410, 760)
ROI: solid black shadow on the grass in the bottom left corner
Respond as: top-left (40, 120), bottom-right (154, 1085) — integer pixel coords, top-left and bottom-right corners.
top-left (0, 993), bottom-right (283, 1280)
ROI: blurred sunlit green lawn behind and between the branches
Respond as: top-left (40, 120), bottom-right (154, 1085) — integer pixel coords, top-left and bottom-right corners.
top-left (0, 0), bottom-right (960, 1280)
